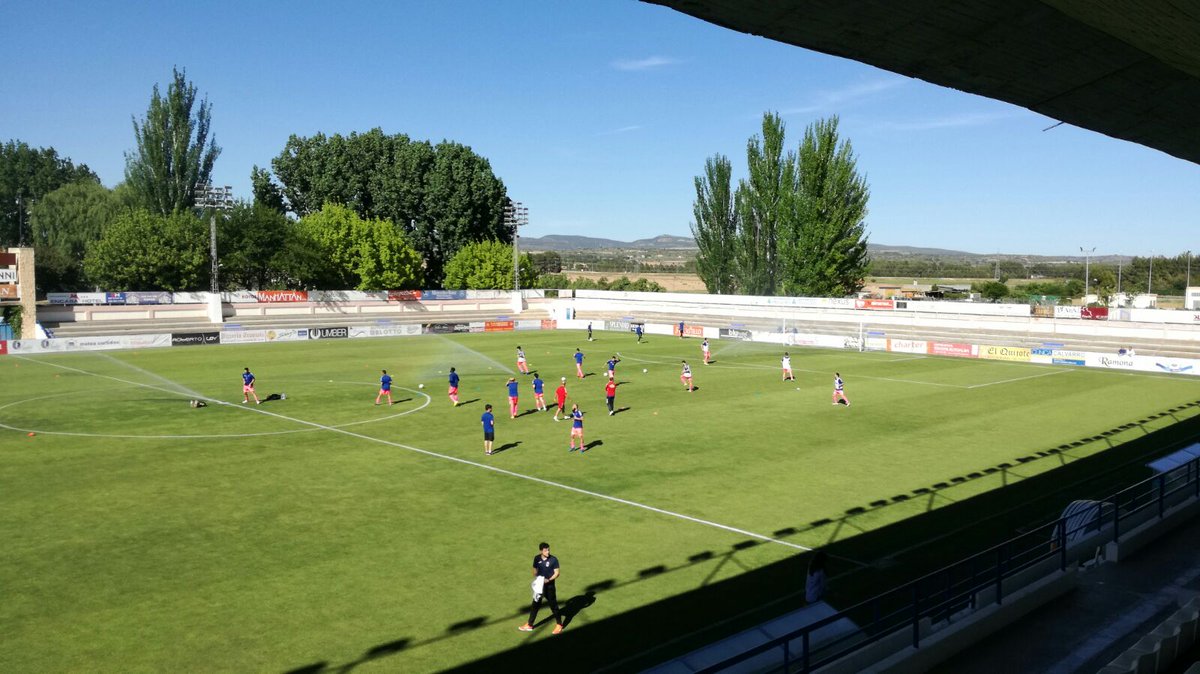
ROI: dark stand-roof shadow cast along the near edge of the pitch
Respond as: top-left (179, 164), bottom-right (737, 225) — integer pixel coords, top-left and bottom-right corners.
top-left (278, 407), bottom-right (1200, 674)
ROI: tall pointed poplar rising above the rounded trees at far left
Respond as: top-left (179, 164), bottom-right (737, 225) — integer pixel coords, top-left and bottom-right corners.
top-left (125, 68), bottom-right (221, 215)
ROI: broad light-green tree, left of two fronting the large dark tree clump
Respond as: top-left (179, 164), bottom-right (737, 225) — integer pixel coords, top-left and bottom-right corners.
top-left (299, 204), bottom-right (421, 290)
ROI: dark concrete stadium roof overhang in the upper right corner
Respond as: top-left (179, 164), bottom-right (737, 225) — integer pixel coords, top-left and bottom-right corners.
top-left (644, 0), bottom-right (1200, 163)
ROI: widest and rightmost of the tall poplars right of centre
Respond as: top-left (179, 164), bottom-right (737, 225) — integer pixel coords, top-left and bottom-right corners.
top-left (781, 116), bottom-right (870, 297)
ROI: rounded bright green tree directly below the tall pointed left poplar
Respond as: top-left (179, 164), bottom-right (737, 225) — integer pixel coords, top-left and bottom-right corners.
top-left (83, 209), bottom-right (209, 291)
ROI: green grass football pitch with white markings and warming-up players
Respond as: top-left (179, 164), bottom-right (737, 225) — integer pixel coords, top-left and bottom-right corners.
top-left (0, 331), bottom-right (1200, 672)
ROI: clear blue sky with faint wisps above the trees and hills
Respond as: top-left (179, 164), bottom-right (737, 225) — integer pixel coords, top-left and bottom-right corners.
top-left (0, 0), bottom-right (1200, 255)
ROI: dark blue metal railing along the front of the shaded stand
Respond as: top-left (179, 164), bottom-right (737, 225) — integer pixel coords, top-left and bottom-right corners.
top-left (701, 458), bottom-right (1200, 674)
